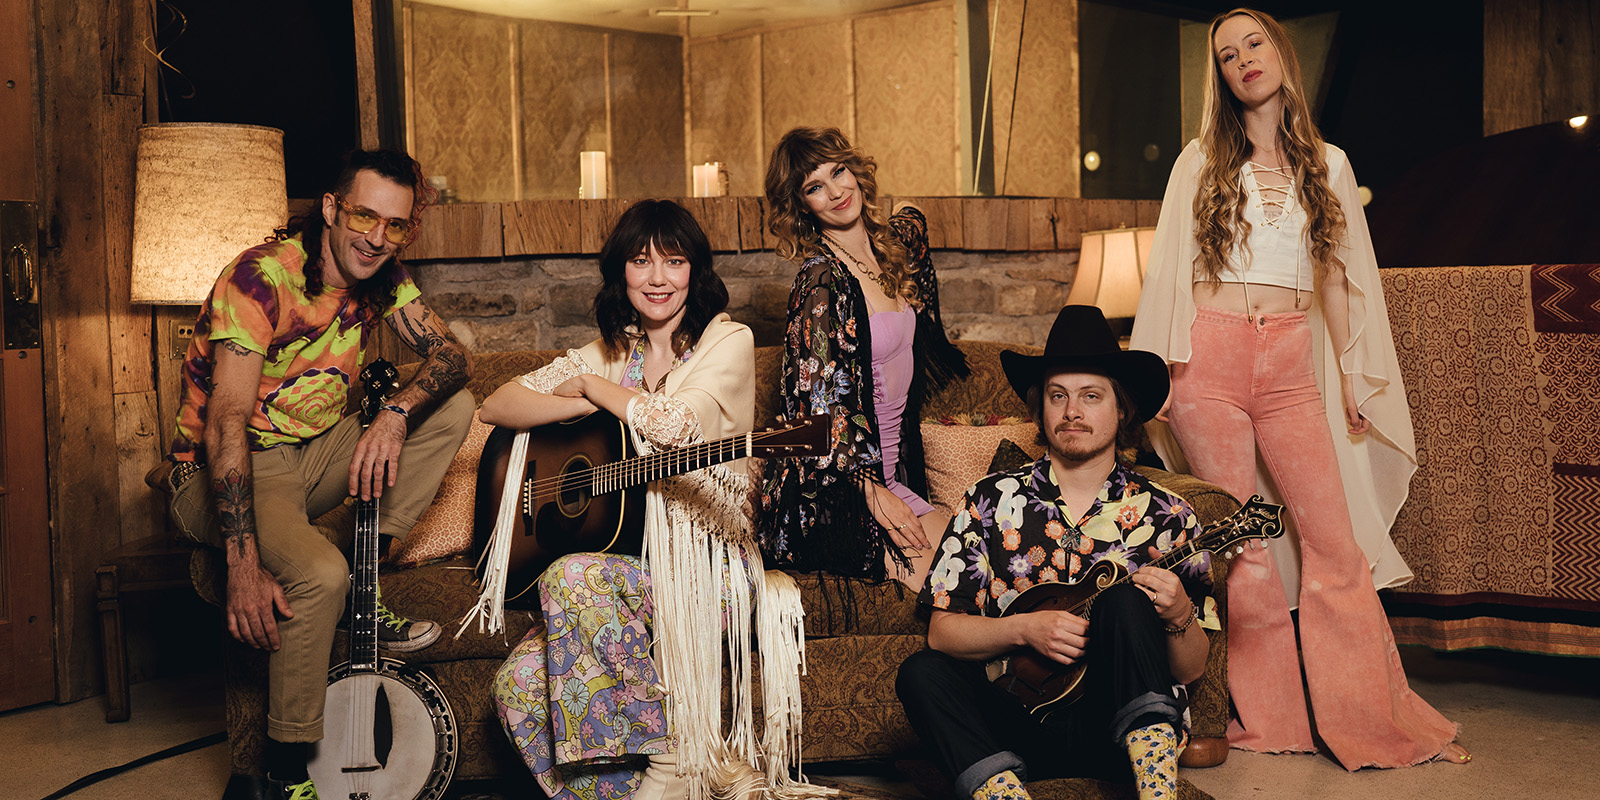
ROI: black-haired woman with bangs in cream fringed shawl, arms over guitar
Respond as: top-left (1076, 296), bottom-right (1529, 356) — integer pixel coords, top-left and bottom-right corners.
top-left (480, 200), bottom-right (812, 800)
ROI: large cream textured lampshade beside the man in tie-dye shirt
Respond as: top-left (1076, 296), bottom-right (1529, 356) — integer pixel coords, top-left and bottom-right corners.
top-left (130, 122), bottom-right (288, 306)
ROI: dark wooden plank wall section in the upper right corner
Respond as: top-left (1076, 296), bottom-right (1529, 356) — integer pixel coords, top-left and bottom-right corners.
top-left (1483, 0), bottom-right (1600, 136)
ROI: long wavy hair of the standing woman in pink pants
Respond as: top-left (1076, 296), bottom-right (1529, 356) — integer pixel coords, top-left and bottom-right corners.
top-left (1194, 8), bottom-right (1344, 283)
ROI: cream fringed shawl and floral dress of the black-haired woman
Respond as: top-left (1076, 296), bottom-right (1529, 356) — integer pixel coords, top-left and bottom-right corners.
top-left (493, 315), bottom-right (812, 800)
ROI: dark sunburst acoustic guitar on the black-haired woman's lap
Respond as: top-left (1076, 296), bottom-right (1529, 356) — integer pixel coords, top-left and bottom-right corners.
top-left (474, 411), bottom-right (829, 603)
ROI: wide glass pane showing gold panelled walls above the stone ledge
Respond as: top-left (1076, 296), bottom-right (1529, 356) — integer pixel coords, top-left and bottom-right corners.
top-left (394, 0), bottom-right (1078, 202)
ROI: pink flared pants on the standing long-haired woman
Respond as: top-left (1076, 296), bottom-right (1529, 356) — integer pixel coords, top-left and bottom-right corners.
top-left (1168, 307), bottom-right (1456, 770)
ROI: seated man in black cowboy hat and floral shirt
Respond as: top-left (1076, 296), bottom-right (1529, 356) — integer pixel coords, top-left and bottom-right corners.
top-left (898, 306), bottom-right (1210, 800)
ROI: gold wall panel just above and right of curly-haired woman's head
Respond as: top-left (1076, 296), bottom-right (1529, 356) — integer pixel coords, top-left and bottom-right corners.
top-left (854, 3), bottom-right (962, 195)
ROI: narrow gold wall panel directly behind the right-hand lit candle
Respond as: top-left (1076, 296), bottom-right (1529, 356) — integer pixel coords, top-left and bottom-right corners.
top-left (690, 35), bottom-right (766, 195)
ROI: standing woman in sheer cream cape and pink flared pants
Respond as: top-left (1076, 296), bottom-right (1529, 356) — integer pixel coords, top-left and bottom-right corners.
top-left (1131, 10), bottom-right (1470, 770)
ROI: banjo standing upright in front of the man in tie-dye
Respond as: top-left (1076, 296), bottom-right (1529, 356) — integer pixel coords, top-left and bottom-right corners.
top-left (306, 360), bottom-right (459, 800)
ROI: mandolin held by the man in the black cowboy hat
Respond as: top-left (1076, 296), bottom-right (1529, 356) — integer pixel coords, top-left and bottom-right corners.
top-left (989, 494), bottom-right (1283, 718)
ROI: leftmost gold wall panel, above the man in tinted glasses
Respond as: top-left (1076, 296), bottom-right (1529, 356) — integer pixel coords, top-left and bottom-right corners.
top-left (410, 5), bottom-right (515, 202)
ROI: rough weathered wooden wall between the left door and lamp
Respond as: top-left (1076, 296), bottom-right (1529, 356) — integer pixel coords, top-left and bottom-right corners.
top-left (35, 0), bottom-right (168, 701)
